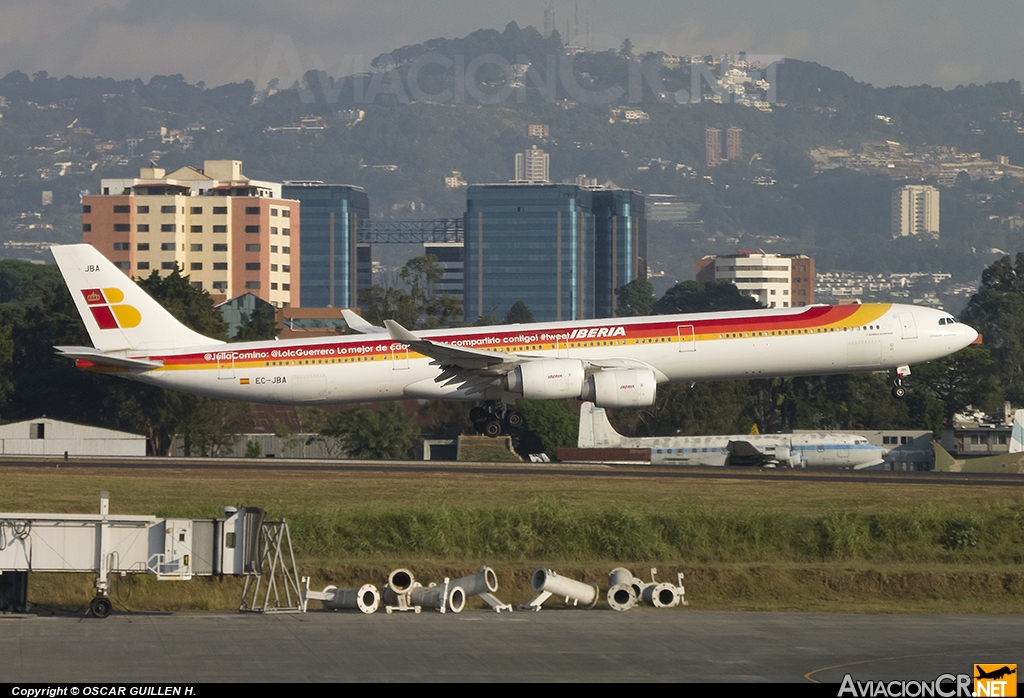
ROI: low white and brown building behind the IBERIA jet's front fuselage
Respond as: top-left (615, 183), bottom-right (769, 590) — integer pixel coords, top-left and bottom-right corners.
top-left (696, 252), bottom-right (814, 308)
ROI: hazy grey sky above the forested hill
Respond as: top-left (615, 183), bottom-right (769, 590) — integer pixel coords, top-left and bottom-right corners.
top-left (0, 0), bottom-right (1024, 87)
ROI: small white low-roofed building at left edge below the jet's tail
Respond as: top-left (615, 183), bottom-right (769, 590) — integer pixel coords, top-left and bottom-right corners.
top-left (0, 417), bottom-right (145, 456)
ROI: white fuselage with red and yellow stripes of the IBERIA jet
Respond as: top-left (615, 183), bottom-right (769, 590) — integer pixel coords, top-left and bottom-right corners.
top-left (99, 304), bottom-right (977, 404)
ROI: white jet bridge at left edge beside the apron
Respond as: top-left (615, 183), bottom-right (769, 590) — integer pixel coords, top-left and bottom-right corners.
top-left (0, 491), bottom-right (264, 617)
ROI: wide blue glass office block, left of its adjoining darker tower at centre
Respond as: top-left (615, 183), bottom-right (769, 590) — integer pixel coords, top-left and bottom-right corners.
top-left (462, 184), bottom-right (595, 322)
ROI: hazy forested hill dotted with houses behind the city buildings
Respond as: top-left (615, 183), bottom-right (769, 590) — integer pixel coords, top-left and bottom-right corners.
top-left (0, 24), bottom-right (1024, 279)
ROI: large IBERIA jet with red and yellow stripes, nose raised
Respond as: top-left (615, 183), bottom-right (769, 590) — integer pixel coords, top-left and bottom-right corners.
top-left (50, 245), bottom-right (978, 436)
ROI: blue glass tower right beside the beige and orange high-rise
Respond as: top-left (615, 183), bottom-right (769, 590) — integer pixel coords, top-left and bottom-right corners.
top-left (282, 181), bottom-right (371, 308)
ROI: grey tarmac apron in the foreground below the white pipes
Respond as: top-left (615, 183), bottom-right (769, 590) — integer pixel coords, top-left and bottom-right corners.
top-left (0, 608), bottom-right (1024, 685)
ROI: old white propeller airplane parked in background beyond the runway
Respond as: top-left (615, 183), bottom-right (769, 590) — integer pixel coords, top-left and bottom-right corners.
top-left (577, 402), bottom-right (889, 470)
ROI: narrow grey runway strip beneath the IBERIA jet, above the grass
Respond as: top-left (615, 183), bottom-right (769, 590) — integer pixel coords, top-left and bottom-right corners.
top-left (0, 456), bottom-right (1024, 487)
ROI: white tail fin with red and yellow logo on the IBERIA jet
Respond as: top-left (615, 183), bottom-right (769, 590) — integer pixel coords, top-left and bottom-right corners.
top-left (50, 245), bottom-right (223, 352)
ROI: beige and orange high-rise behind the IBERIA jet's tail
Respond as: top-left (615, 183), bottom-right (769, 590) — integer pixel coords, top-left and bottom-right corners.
top-left (82, 160), bottom-right (301, 307)
